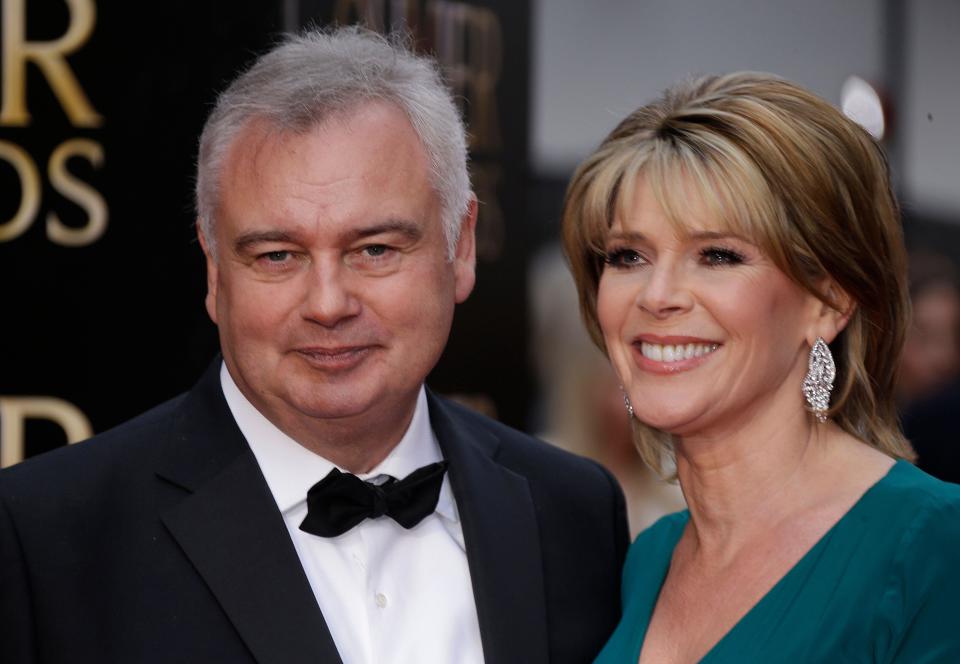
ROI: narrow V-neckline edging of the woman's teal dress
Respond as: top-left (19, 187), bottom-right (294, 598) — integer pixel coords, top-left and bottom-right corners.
top-left (631, 459), bottom-right (912, 662)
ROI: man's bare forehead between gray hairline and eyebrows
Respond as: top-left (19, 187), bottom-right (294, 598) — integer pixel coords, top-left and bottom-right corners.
top-left (210, 103), bottom-right (442, 250)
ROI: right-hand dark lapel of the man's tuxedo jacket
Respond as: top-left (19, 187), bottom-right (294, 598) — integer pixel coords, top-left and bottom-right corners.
top-left (428, 393), bottom-right (548, 664)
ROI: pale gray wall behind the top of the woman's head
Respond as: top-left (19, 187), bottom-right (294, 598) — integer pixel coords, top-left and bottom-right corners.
top-left (530, 0), bottom-right (960, 221)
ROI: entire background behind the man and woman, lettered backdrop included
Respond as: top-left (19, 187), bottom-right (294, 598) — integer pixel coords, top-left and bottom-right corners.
top-left (0, 0), bottom-right (960, 529)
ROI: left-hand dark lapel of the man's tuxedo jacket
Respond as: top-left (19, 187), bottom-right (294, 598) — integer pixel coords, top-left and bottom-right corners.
top-left (158, 362), bottom-right (341, 664)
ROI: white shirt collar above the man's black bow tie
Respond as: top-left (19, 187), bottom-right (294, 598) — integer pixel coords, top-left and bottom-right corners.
top-left (220, 363), bottom-right (459, 522)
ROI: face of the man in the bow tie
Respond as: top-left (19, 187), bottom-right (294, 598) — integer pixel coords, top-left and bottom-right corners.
top-left (202, 103), bottom-right (476, 442)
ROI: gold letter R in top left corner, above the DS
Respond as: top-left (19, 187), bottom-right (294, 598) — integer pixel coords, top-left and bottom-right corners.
top-left (0, 0), bottom-right (103, 127)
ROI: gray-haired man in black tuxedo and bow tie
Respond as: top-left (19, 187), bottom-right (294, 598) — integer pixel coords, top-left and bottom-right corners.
top-left (0, 28), bottom-right (627, 664)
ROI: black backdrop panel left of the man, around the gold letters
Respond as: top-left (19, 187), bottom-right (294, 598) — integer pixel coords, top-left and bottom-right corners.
top-left (0, 0), bottom-right (280, 455)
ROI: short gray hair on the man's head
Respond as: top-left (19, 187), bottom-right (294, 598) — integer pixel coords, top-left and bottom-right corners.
top-left (196, 26), bottom-right (471, 259)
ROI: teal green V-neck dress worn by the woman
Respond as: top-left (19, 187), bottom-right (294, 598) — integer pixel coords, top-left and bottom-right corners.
top-left (596, 461), bottom-right (960, 664)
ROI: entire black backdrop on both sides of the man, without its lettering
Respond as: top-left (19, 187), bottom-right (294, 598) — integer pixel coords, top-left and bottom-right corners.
top-left (0, 0), bottom-right (530, 456)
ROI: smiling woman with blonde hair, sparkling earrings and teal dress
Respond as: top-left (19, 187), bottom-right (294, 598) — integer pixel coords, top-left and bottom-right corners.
top-left (563, 73), bottom-right (960, 663)
